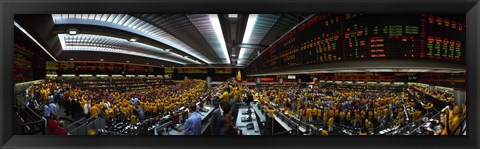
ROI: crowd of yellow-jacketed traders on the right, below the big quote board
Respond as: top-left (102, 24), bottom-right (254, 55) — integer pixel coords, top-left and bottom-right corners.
top-left (249, 84), bottom-right (424, 134)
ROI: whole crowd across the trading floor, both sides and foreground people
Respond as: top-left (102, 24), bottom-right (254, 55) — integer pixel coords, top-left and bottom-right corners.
top-left (19, 79), bottom-right (466, 135)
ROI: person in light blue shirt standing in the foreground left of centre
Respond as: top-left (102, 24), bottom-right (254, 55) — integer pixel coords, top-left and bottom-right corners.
top-left (183, 103), bottom-right (202, 135)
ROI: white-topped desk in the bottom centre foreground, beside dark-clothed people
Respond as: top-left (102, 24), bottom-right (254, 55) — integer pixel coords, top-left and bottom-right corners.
top-left (236, 107), bottom-right (260, 135)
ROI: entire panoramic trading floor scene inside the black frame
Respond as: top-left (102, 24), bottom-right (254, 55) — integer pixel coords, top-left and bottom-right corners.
top-left (12, 13), bottom-right (464, 136)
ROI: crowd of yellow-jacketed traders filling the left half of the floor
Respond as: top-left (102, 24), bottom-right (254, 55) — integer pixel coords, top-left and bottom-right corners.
top-left (25, 80), bottom-right (205, 135)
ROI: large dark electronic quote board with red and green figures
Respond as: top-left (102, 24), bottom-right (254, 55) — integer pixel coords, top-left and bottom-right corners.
top-left (247, 13), bottom-right (466, 73)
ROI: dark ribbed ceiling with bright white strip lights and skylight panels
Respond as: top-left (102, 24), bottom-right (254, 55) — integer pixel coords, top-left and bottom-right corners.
top-left (15, 14), bottom-right (310, 67)
